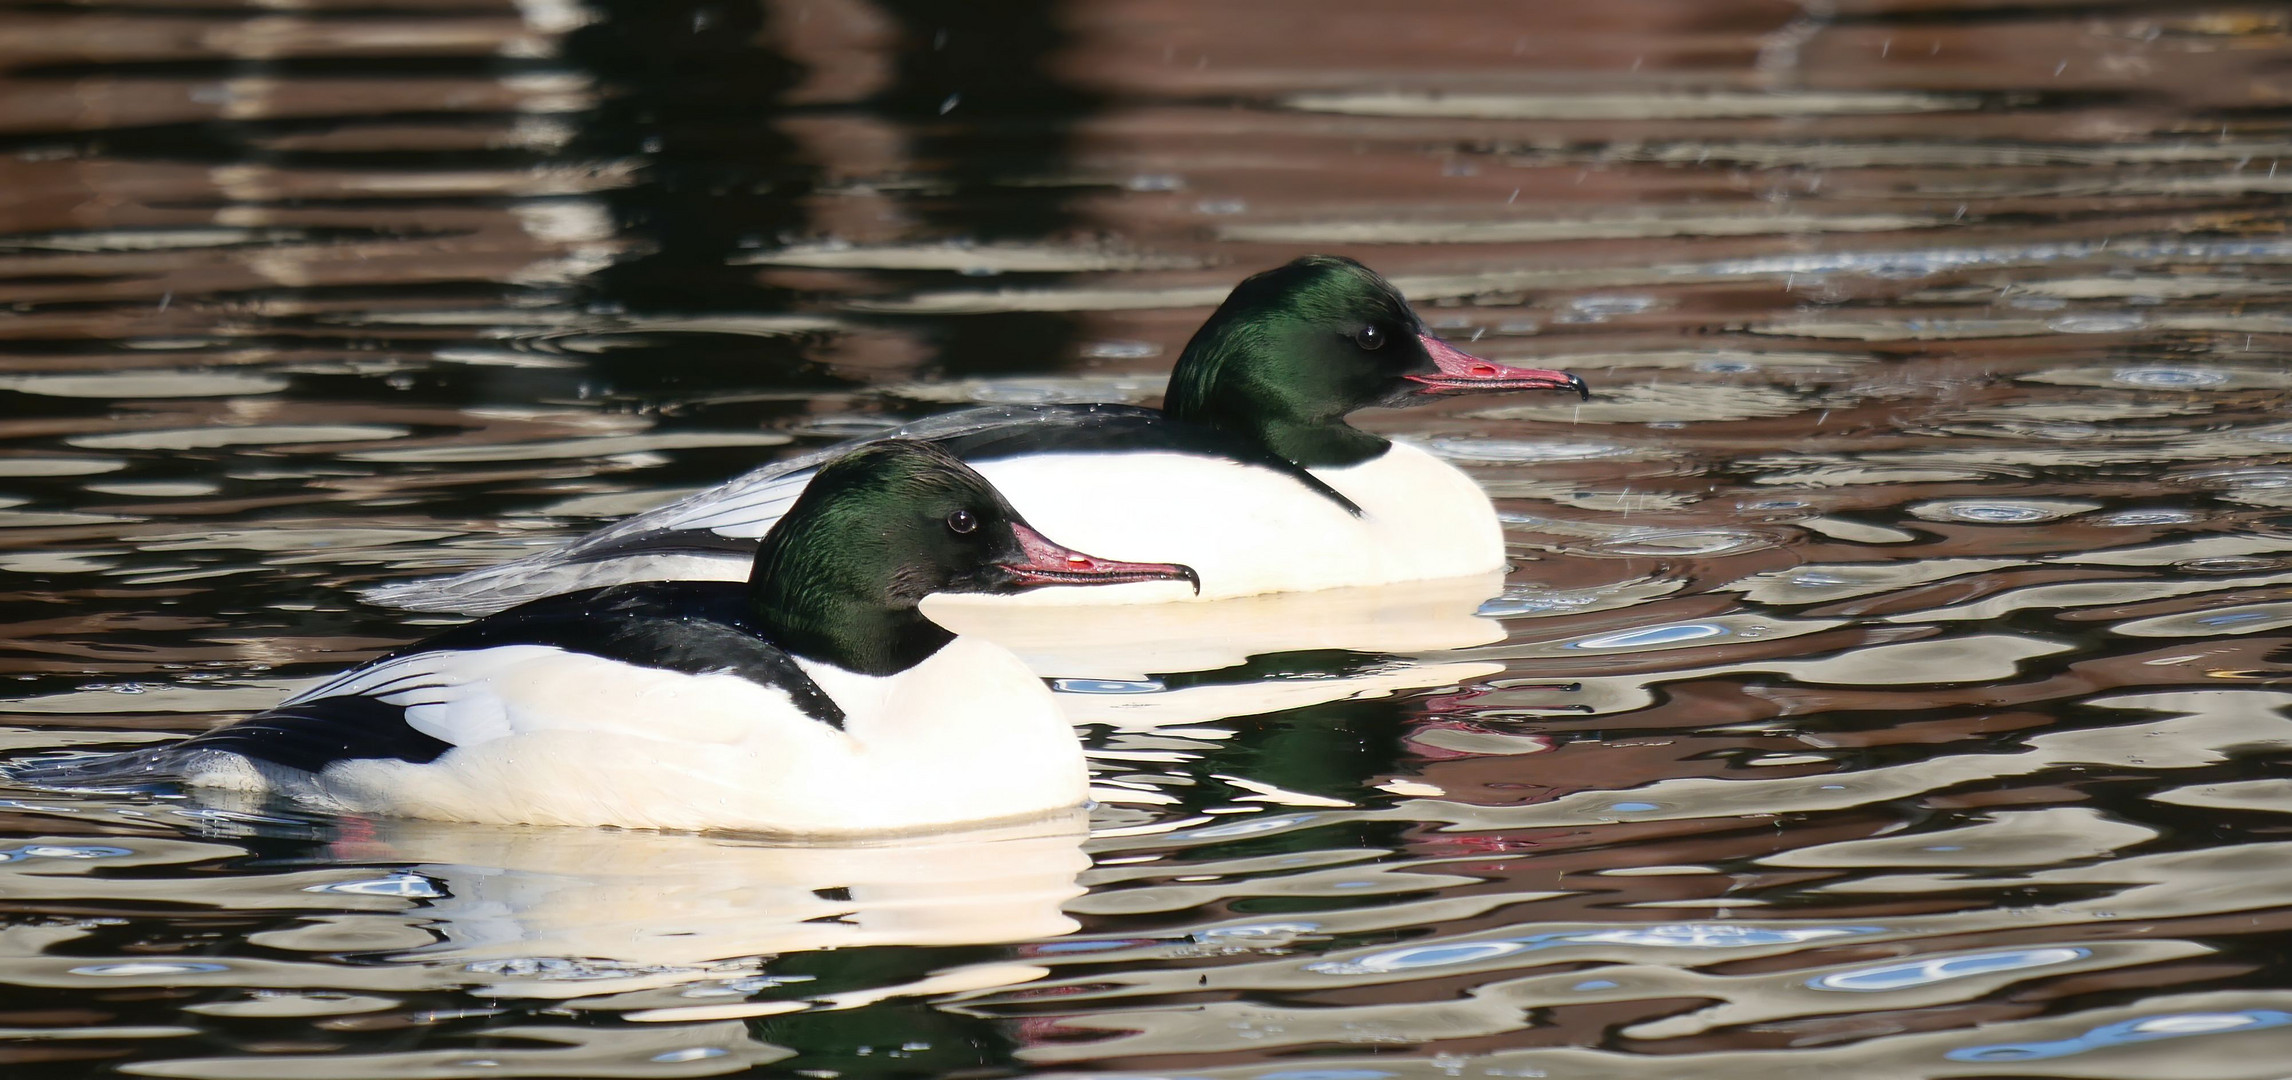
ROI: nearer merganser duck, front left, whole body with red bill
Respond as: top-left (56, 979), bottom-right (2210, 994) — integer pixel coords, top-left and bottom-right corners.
top-left (16, 440), bottom-right (1194, 835)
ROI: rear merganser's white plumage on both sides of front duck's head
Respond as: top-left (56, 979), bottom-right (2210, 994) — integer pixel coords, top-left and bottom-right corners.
top-left (371, 443), bottom-right (1504, 612)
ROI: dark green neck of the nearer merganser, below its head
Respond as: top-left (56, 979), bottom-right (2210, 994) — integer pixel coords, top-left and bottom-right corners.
top-left (749, 534), bottom-right (956, 674)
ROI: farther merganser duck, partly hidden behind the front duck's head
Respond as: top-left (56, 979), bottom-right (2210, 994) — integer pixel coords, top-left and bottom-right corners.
top-left (367, 255), bottom-right (1591, 615)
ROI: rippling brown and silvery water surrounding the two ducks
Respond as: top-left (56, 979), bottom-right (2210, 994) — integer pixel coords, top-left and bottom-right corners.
top-left (0, 0), bottom-right (2292, 1080)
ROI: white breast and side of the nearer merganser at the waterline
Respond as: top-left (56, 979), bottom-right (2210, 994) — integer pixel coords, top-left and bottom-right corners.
top-left (234, 637), bottom-right (1089, 835)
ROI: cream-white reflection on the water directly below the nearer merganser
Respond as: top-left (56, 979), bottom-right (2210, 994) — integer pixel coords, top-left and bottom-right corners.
top-left (302, 812), bottom-right (1091, 999)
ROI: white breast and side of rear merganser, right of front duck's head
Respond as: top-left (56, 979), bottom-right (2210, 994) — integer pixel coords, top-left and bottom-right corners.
top-left (949, 443), bottom-right (1504, 605)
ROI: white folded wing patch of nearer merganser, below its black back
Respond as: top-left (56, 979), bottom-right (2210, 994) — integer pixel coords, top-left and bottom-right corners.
top-left (287, 644), bottom-right (821, 748)
